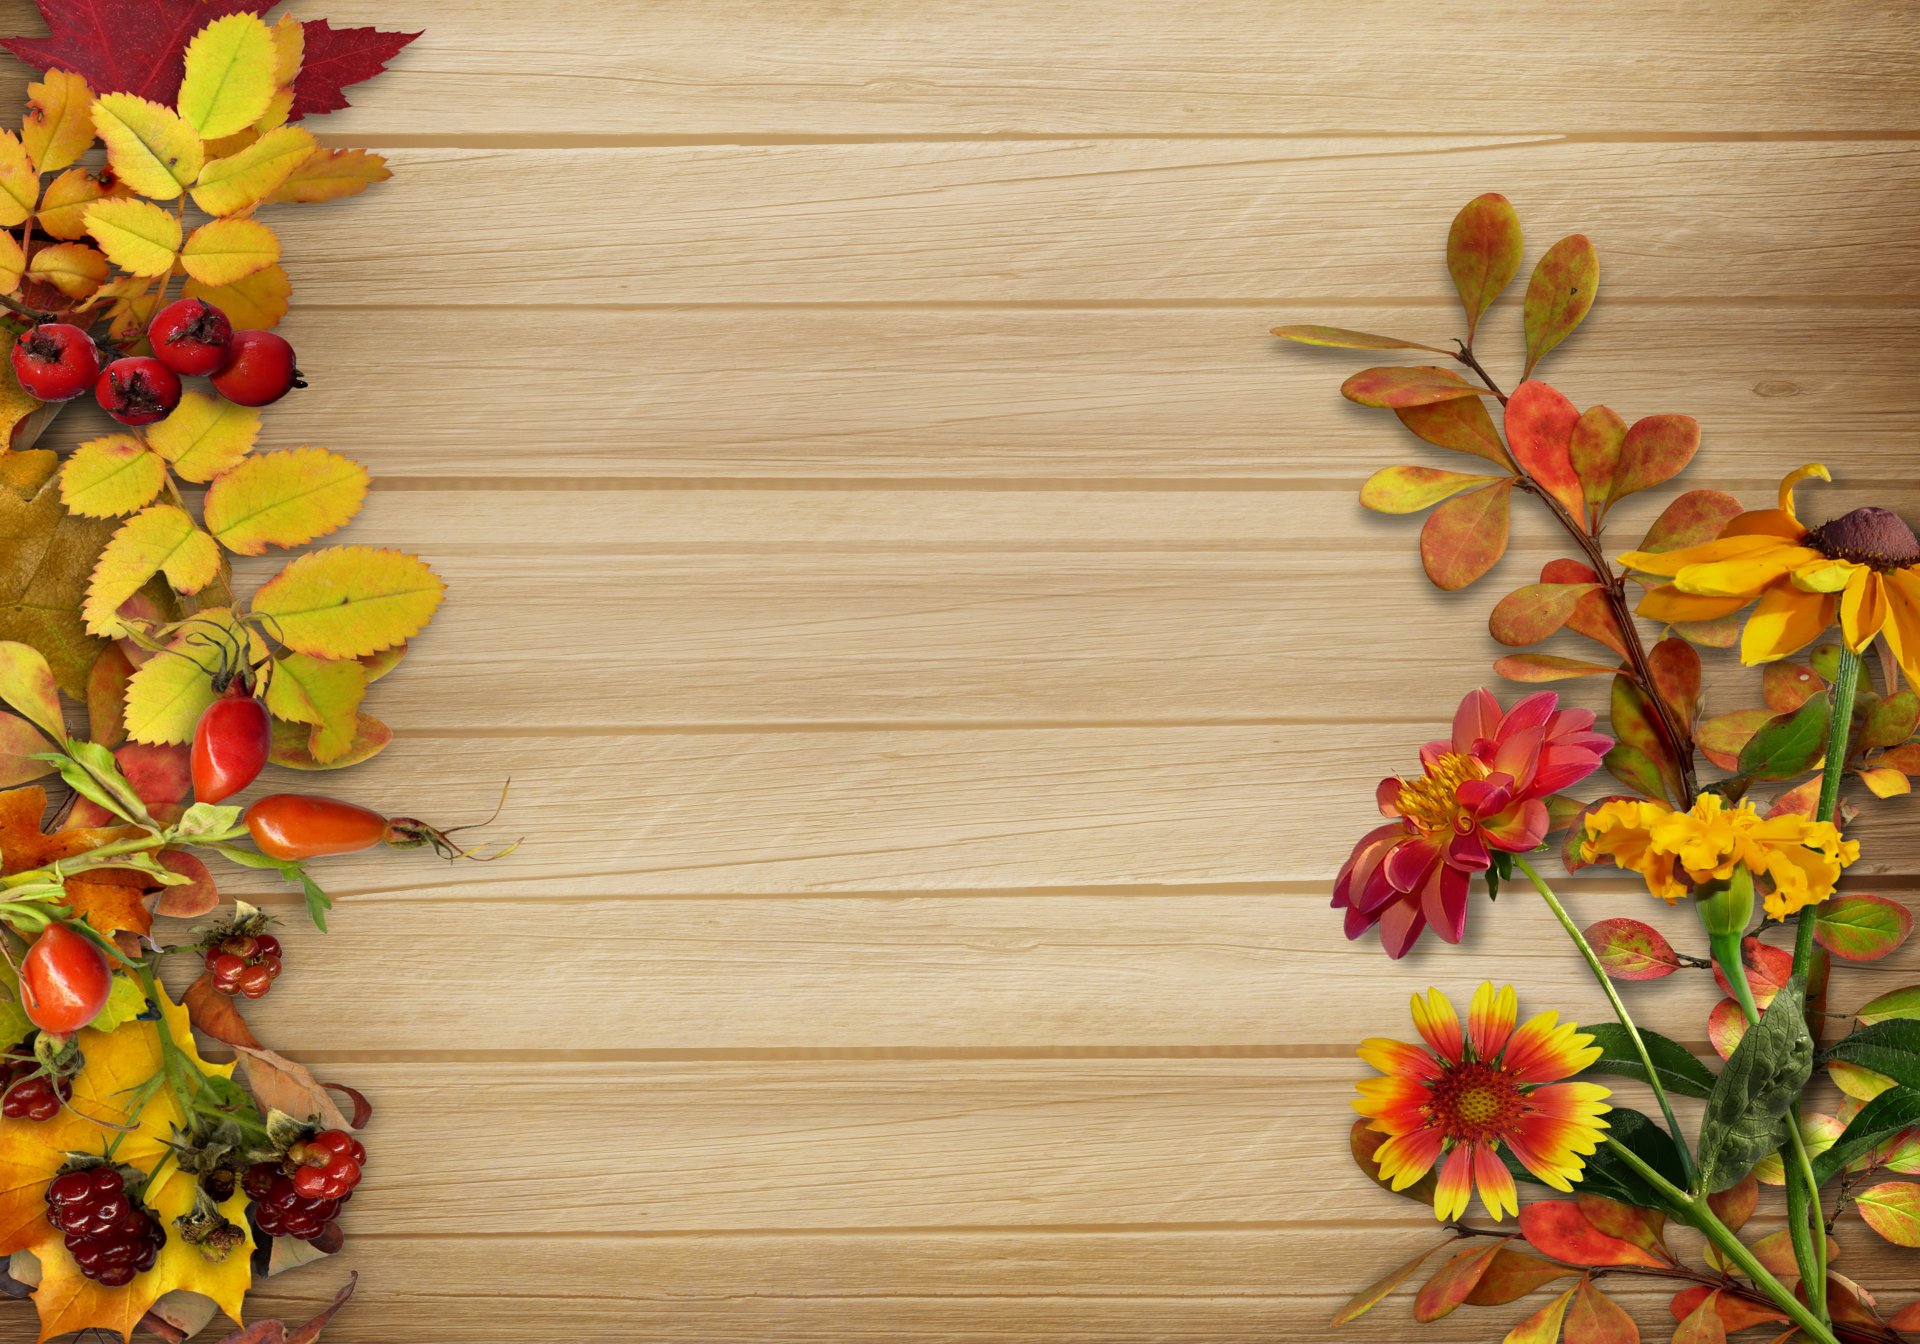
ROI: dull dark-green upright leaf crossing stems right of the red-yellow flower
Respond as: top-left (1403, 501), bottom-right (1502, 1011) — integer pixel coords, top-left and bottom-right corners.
top-left (1699, 975), bottom-right (1814, 1194)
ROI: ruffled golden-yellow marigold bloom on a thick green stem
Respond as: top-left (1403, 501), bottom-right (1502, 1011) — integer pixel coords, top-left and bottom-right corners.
top-left (1580, 793), bottom-right (1860, 920)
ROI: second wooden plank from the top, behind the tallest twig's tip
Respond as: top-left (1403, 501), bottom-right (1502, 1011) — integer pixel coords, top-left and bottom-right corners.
top-left (266, 134), bottom-right (1920, 301)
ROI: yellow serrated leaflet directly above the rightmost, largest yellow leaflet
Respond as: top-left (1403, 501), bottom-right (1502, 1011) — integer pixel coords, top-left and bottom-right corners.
top-left (204, 447), bottom-right (367, 555)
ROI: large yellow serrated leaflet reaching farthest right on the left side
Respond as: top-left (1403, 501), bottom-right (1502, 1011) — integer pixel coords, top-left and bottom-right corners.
top-left (253, 545), bottom-right (447, 659)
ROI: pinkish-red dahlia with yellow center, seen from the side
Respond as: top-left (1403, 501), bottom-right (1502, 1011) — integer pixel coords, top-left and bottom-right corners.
top-left (1332, 689), bottom-right (1613, 956)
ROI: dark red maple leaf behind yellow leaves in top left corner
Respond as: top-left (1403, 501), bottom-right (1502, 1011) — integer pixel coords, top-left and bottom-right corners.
top-left (0, 0), bottom-right (419, 119)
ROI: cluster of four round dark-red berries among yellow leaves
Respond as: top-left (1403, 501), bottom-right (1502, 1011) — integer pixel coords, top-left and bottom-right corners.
top-left (13, 300), bottom-right (307, 424)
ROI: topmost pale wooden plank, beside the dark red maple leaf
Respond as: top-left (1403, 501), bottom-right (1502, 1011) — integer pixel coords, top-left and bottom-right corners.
top-left (4, 0), bottom-right (1916, 140)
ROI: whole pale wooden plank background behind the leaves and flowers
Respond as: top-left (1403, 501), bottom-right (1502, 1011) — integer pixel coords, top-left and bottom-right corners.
top-left (0, 0), bottom-right (1920, 1344)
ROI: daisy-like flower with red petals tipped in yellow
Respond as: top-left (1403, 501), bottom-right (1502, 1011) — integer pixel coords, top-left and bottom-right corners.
top-left (1354, 981), bottom-right (1613, 1221)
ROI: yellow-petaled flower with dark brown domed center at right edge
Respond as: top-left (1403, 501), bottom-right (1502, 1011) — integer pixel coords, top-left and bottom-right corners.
top-left (1620, 463), bottom-right (1920, 682)
